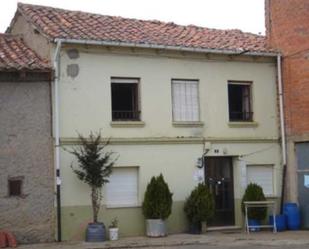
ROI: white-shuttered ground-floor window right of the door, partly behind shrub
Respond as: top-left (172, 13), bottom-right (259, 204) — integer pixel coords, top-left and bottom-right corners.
top-left (247, 165), bottom-right (274, 196)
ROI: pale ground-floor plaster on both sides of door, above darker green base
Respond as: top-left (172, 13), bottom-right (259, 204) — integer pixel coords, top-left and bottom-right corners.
top-left (61, 143), bottom-right (282, 206)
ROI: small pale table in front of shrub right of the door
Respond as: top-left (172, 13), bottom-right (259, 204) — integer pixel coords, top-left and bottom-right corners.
top-left (244, 201), bottom-right (277, 233)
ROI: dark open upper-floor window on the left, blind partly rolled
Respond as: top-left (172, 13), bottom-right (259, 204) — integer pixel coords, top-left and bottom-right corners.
top-left (111, 77), bottom-right (141, 121)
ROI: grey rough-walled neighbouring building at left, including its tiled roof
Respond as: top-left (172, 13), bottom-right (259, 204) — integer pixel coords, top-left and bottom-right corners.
top-left (0, 34), bottom-right (54, 243)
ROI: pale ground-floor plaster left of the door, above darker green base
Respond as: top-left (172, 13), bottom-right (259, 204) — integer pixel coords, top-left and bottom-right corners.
top-left (61, 144), bottom-right (203, 206)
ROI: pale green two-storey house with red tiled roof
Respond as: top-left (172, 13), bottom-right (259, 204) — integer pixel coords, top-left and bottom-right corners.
top-left (8, 1), bottom-right (283, 240)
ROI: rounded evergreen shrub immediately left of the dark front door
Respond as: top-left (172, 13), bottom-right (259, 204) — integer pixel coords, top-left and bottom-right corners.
top-left (184, 183), bottom-right (215, 234)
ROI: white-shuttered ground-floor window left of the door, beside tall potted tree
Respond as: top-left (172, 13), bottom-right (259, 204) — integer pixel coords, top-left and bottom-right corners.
top-left (105, 167), bottom-right (138, 207)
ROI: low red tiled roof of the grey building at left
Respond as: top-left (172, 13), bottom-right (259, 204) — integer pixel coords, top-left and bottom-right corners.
top-left (0, 34), bottom-right (51, 71)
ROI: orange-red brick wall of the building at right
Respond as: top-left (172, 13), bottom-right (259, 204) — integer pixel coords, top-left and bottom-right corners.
top-left (265, 0), bottom-right (309, 136)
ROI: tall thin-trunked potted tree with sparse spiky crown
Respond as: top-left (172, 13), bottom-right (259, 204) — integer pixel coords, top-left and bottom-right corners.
top-left (66, 132), bottom-right (117, 242)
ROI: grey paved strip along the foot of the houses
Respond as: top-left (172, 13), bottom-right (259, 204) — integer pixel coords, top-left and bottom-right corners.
top-left (19, 231), bottom-right (309, 249)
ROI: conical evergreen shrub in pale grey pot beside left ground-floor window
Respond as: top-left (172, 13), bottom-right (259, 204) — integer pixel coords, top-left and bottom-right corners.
top-left (142, 174), bottom-right (173, 237)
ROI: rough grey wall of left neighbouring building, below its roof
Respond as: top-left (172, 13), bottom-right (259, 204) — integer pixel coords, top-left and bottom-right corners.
top-left (0, 79), bottom-right (54, 243)
